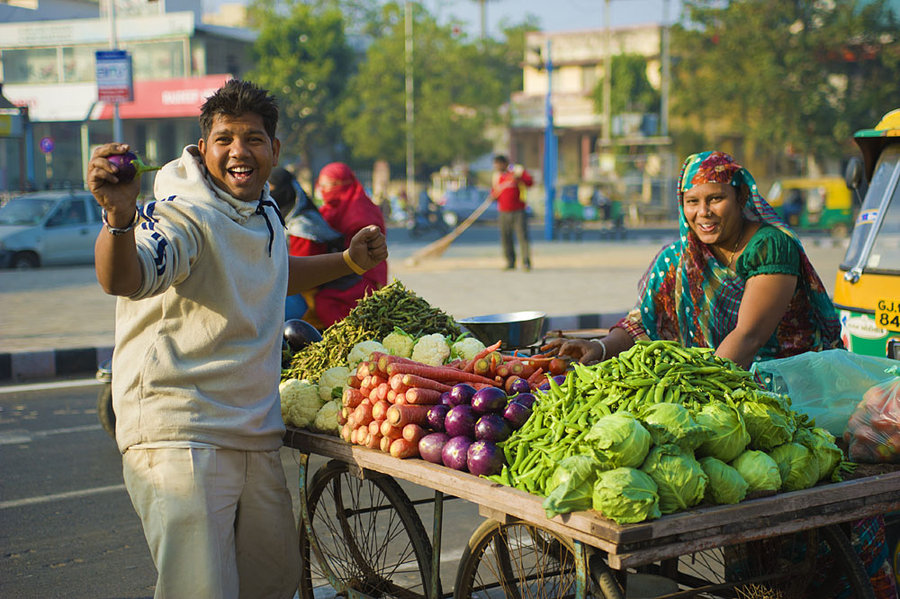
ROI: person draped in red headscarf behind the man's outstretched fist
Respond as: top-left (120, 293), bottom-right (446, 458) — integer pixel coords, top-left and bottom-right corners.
top-left (289, 162), bottom-right (387, 329)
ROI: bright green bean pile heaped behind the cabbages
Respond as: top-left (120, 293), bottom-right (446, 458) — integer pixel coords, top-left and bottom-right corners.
top-left (500, 341), bottom-right (761, 496)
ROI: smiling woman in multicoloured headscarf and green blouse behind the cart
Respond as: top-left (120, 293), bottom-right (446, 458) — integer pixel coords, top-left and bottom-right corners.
top-left (547, 152), bottom-right (896, 599)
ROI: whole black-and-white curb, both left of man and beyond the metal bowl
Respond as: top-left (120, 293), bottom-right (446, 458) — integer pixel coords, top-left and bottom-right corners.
top-left (0, 312), bottom-right (625, 383)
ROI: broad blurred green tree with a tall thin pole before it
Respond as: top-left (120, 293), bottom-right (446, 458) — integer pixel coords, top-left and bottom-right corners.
top-left (337, 2), bottom-right (509, 173)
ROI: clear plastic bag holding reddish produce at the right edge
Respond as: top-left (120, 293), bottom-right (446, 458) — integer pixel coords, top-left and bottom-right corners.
top-left (844, 366), bottom-right (900, 464)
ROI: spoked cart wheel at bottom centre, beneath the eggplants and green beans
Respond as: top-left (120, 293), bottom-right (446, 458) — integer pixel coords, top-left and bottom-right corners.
top-left (453, 520), bottom-right (615, 599)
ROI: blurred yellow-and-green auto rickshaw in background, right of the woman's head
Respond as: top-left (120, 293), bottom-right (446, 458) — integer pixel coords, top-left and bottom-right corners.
top-left (766, 176), bottom-right (853, 239)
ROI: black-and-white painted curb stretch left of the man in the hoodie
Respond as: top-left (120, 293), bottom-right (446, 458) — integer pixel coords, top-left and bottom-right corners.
top-left (0, 347), bottom-right (113, 383)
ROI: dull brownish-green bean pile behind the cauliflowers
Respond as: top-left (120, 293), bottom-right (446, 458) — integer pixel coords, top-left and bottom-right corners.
top-left (282, 280), bottom-right (460, 381)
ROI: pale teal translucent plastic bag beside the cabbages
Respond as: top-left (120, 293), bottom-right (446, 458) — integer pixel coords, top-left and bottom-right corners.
top-left (751, 349), bottom-right (897, 437)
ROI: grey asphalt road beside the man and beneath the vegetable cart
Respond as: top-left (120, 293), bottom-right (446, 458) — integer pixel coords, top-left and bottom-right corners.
top-left (0, 381), bottom-right (481, 599)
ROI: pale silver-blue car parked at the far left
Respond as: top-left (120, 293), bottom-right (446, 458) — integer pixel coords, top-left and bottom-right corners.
top-left (0, 191), bottom-right (102, 268)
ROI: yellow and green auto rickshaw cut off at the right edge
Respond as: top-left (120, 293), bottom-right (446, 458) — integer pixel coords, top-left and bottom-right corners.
top-left (834, 109), bottom-right (900, 359)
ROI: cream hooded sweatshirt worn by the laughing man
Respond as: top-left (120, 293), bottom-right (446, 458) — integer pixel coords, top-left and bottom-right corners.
top-left (112, 146), bottom-right (288, 452)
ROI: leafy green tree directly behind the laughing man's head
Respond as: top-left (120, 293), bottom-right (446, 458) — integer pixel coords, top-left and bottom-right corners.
top-left (250, 0), bottom-right (354, 164)
